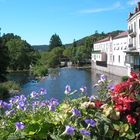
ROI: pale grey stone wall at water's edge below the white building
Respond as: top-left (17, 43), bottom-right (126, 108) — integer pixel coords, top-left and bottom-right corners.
top-left (92, 61), bottom-right (128, 76)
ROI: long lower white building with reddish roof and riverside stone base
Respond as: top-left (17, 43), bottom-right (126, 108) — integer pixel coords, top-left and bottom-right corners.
top-left (92, 32), bottom-right (128, 76)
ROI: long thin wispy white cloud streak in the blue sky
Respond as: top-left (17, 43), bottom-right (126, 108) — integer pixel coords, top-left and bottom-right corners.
top-left (79, 1), bottom-right (122, 14)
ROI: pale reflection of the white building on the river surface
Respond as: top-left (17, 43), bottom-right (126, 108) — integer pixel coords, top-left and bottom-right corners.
top-left (91, 69), bottom-right (121, 85)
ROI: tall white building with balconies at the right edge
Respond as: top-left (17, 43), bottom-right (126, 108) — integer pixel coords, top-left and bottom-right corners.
top-left (126, 2), bottom-right (140, 71)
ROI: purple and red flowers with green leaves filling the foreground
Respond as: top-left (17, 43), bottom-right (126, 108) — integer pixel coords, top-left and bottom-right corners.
top-left (0, 72), bottom-right (140, 140)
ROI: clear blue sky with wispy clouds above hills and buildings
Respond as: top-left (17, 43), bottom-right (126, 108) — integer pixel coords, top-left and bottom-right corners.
top-left (0, 0), bottom-right (140, 45)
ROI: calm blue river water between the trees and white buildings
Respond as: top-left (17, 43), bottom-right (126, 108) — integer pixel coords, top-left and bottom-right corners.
top-left (8, 68), bottom-right (121, 101)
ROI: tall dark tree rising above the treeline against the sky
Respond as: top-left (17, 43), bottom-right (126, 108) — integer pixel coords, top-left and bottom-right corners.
top-left (49, 34), bottom-right (62, 50)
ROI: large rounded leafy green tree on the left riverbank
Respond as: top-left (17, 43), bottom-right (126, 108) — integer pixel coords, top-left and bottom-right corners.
top-left (2, 33), bottom-right (39, 70)
